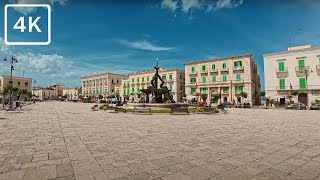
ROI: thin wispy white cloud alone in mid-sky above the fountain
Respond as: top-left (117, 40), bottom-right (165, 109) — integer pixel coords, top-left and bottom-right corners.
top-left (118, 40), bottom-right (174, 51)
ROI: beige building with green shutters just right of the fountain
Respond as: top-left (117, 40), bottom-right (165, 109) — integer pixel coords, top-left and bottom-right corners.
top-left (185, 54), bottom-right (260, 105)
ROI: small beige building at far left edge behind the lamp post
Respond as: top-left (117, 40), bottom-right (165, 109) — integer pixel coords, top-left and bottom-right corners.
top-left (0, 76), bottom-right (32, 92)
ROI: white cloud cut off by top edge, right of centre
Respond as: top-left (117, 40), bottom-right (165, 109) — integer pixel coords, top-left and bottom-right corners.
top-left (161, 0), bottom-right (244, 13)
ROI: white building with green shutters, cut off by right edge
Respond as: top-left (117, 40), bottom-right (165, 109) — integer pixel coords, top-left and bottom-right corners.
top-left (263, 45), bottom-right (320, 105)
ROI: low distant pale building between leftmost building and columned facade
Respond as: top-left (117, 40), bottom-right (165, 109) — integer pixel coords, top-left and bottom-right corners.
top-left (32, 87), bottom-right (59, 101)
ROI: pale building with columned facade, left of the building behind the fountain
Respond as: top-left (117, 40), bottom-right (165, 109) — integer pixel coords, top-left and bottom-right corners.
top-left (81, 73), bottom-right (128, 97)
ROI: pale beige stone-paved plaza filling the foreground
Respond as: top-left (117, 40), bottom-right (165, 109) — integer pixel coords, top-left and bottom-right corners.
top-left (0, 102), bottom-right (320, 180)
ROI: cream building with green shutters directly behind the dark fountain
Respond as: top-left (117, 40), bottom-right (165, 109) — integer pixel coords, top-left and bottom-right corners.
top-left (118, 68), bottom-right (185, 102)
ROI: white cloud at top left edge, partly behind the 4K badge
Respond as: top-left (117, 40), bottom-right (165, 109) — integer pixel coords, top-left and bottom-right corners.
top-left (10, 0), bottom-right (68, 15)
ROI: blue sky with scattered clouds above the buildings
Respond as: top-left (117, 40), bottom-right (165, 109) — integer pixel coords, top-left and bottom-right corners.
top-left (0, 0), bottom-right (320, 88)
